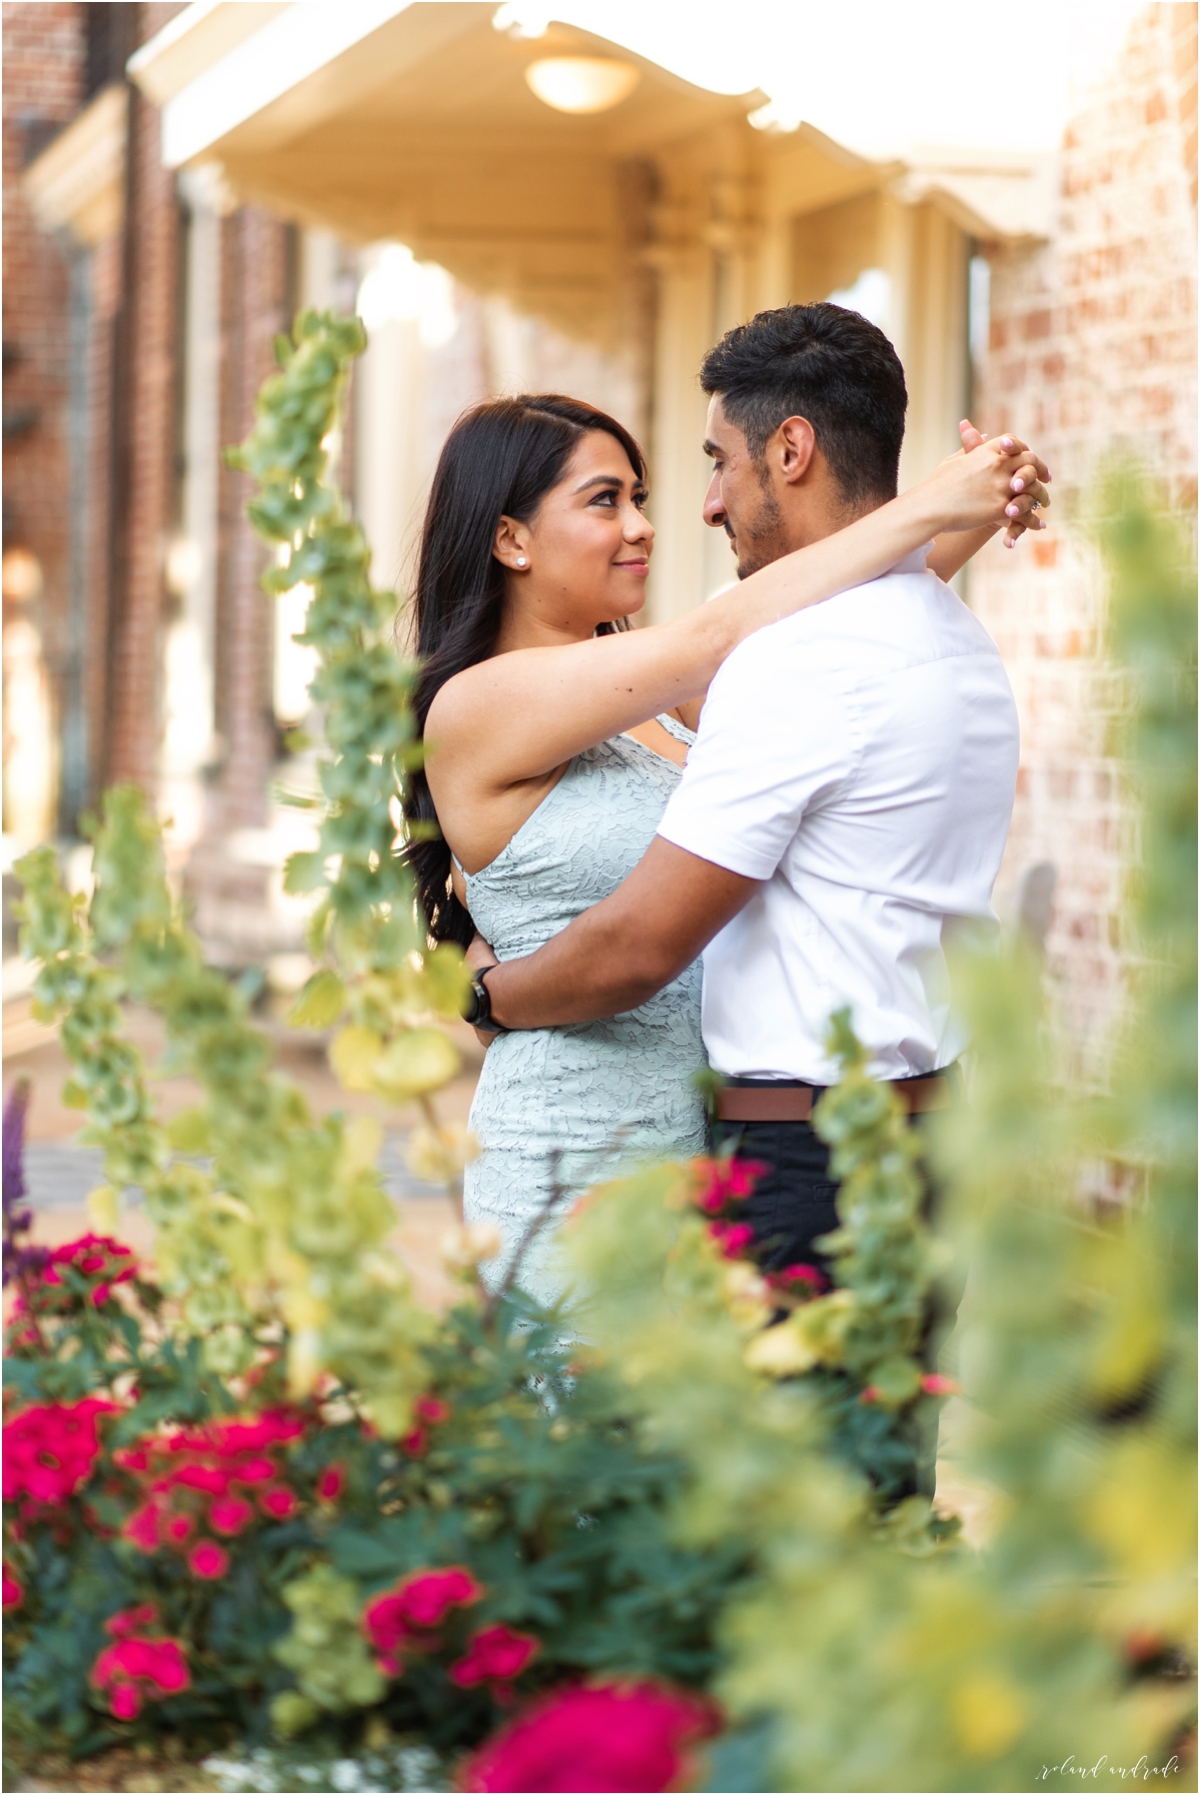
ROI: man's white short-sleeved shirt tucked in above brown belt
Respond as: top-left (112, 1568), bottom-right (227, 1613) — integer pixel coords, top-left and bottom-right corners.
top-left (658, 549), bottom-right (1019, 1084)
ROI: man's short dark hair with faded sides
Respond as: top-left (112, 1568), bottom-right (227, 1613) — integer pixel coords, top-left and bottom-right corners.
top-left (700, 300), bottom-right (908, 504)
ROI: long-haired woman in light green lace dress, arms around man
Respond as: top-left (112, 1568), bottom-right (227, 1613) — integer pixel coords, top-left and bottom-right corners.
top-left (407, 395), bottom-right (1044, 1300)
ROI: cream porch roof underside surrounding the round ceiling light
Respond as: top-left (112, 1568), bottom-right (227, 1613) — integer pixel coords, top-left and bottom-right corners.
top-left (129, 0), bottom-right (1040, 343)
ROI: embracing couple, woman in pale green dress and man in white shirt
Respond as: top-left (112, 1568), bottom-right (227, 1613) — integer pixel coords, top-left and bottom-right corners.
top-left (407, 303), bottom-right (1049, 1371)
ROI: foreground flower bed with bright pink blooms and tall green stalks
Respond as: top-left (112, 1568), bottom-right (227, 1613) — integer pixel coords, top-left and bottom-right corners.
top-left (4, 314), bottom-right (1195, 1790)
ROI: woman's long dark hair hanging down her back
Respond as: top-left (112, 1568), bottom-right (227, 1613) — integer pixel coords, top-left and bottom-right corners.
top-left (404, 393), bottom-right (646, 948)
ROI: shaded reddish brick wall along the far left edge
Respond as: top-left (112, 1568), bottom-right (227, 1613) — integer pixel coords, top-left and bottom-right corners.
top-left (4, 4), bottom-right (83, 836)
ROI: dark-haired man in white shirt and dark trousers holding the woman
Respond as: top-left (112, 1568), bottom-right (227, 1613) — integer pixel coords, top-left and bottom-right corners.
top-left (473, 303), bottom-right (1046, 1349)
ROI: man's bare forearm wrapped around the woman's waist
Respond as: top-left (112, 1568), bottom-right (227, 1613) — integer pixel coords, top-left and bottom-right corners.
top-left (488, 835), bottom-right (759, 1029)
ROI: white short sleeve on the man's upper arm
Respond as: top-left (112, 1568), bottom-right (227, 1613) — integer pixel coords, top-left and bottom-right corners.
top-left (658, 628), bottom-right (854, 880)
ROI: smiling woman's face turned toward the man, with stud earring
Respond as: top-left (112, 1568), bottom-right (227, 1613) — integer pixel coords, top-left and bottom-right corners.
top-left (495, 431), bottom-right (655, 639)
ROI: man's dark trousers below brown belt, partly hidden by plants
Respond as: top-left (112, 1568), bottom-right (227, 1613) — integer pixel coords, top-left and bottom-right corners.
top-left (712, 1079), bottom-right (965, 1497)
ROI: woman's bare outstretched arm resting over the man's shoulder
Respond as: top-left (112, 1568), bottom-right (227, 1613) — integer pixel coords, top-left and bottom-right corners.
top-left (425, 436), bottom-right (1044, 801)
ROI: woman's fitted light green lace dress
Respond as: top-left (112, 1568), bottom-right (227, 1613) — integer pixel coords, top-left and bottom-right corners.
top-left (455, 716), bottom-right (705, 1301)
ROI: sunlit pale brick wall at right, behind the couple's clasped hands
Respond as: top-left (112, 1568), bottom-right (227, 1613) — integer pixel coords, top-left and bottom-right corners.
top-left (970, 4), bottom-right (1196, 1061)
